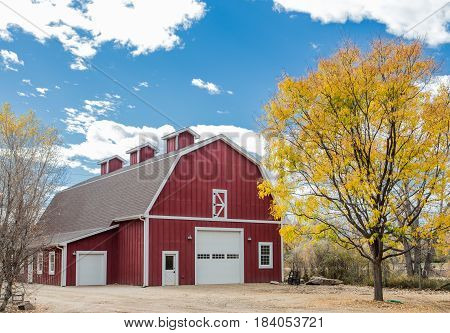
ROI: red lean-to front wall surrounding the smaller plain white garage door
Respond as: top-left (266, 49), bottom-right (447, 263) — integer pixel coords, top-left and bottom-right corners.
top-left (66, 229), bottom-right (118, 286)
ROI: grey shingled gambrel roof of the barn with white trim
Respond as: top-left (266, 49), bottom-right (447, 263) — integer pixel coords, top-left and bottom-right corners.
top-left (41, 135), bottom-right (265, 244)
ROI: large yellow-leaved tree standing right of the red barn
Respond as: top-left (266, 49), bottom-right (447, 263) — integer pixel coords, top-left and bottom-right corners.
top-left (259, 40), bottom-right (450, 301)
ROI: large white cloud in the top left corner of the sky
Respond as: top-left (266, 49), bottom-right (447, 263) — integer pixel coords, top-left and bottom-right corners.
top-left (0, 0), bottom-right (206, 70)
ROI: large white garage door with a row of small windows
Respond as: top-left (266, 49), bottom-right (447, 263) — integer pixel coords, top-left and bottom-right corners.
top-left (195, 228), bottom-right (244, 284)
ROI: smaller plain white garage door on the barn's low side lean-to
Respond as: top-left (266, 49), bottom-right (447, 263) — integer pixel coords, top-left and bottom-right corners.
top-left (76, 251), bottom-right (106, 286)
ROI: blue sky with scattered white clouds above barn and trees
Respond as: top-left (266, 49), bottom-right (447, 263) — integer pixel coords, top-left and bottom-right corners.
top-left (0, 0), bottom-right (450, 184)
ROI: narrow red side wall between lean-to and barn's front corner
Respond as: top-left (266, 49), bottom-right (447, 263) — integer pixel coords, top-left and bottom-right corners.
top-left (115, 220), bottom-right (144, 285)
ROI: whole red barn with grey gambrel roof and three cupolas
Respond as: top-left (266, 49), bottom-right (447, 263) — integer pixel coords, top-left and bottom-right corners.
top-left (26, 129), bottom-right (282, 286)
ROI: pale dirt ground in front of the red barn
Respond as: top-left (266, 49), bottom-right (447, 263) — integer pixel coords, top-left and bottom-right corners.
top-left (18, 284), bottom-right (450, 313)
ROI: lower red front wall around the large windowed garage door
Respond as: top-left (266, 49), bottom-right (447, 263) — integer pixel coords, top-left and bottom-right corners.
top-left (149, 219), bottom-right (281, 286)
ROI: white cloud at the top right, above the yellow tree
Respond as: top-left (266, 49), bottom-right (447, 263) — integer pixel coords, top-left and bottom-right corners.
top-left (274, 0), bottom-right (450, 46)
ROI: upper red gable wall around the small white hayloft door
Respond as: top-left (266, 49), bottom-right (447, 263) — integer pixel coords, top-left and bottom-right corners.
top-left (150, 140), bottom-right (273, 220)
